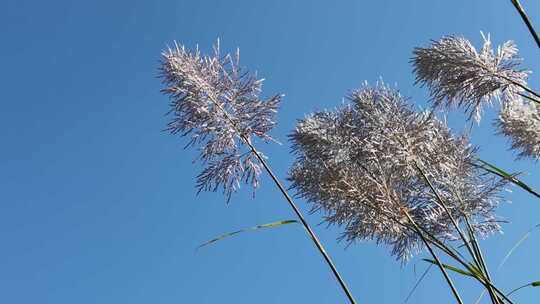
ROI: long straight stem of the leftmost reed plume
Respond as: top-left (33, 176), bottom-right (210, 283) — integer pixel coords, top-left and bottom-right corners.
top-left (209, 96), bottom-right (356, 304)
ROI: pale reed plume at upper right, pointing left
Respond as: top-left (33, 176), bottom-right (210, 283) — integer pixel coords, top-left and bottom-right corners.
top-left (411, 34), bottom-right (528, 122)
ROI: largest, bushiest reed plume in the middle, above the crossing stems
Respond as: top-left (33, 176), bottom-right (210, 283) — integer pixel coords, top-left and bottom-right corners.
top-left (289, 85), bottom-right (505, 261)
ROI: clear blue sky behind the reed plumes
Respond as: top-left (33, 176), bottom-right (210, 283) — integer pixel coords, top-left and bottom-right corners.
top-left (0, 0), bottom-right (540, 304)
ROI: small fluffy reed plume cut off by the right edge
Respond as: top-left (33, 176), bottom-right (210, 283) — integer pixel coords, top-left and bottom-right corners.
top-left (496, 98), bottom-right (540, 160)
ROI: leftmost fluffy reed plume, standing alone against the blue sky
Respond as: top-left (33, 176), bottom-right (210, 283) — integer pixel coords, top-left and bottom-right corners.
top-left (160, 41), bottom-right (282, 200)
